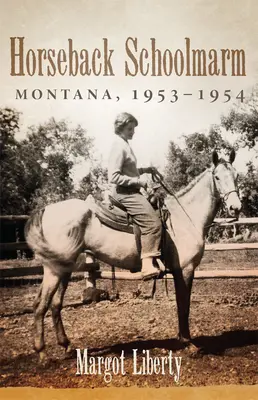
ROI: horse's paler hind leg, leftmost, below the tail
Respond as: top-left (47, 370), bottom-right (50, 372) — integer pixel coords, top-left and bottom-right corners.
top-left (34, 267), bottom-right (60, 359)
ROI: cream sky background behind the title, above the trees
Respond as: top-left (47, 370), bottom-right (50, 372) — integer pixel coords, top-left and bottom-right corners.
top-left (0, 0), bottom-right (258, 177)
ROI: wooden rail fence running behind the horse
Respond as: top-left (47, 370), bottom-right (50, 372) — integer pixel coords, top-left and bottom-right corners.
top-left (0, 215), bottom-right (258, 280)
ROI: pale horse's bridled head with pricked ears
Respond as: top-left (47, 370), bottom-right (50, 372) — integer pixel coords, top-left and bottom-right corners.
top-left (212, 150), bottom-right (241, 217)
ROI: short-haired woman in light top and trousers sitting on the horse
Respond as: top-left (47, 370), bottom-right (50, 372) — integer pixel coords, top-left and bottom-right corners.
top-left (108, 113), bottom-right (164, 280)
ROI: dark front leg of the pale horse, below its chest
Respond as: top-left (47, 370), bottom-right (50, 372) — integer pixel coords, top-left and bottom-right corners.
top-left (174, 264), bottom-right (194, 343)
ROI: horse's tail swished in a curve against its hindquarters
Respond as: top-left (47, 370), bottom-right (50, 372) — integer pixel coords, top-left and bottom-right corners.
top-left (24, 208), bottom-right (82, 265)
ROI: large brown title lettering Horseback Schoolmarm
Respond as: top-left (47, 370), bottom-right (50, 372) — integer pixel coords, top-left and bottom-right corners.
top-left (10, 37), bottom-right (246, 77)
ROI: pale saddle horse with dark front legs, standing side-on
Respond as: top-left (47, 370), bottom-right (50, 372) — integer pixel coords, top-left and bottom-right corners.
top-left (25, 150), bottom-right (241, 360)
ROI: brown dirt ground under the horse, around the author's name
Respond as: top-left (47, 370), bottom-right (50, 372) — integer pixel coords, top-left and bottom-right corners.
top-left (0, 268), bottom-right (258, 388)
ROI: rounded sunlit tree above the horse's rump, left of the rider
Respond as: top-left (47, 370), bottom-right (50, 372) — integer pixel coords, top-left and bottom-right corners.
top-left (21, 118), bottom-right (93, 208)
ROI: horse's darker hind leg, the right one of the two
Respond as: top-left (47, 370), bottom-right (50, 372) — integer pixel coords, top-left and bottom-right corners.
top-left (51, 272), bottom-right (71, 351)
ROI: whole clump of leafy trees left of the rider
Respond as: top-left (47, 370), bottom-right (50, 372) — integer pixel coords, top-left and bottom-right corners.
top-left (0, 108), bottom-right (107, 214)
